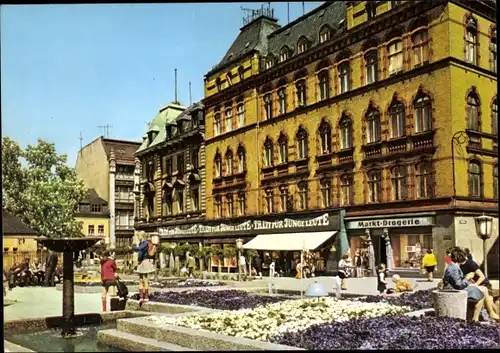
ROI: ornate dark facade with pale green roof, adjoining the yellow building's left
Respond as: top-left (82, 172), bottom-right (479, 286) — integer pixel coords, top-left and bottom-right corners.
top-left (135, 103), bottom-right (206, 238)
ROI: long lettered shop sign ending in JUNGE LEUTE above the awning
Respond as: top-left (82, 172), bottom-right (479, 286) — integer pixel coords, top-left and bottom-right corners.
top-left (158, 213), bottom-right (331, 236)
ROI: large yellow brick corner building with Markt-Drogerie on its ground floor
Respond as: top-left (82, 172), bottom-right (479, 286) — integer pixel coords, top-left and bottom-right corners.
top-left (204, 1), bottom-right (498, 272)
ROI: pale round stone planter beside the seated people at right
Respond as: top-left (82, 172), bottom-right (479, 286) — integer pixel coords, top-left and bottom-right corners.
top-left (432, 290), bottom-right (467, 320)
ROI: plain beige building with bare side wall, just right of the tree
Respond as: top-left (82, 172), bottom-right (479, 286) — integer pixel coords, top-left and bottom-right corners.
top-left (75, 136), bottom-right (140, 248)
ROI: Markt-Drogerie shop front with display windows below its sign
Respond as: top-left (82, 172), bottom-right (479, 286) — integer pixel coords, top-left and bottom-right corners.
top-left (345, 214), bottom-right (438, 274)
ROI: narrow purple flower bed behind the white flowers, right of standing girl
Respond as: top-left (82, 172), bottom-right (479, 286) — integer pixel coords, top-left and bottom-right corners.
top-left (131, 289), bottom-right (290, 310)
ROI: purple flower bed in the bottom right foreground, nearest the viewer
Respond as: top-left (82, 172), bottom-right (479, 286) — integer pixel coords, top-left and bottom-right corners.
top-left (270, 316), bottom-right (500, 350)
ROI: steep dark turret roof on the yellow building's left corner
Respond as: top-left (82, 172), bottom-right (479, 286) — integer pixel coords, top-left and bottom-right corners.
top-left (207, 16), bottom-right (280, 75)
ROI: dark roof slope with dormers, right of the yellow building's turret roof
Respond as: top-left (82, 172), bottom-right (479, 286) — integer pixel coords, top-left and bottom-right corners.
top-left (268, 1), bottom-right (346, 57)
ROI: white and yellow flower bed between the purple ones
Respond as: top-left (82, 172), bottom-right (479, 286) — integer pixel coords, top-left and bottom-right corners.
top-left (148, 298), bottom-right (411, 340)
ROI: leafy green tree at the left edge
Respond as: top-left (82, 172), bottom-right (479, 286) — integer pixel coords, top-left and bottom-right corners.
top-left (2, 137), bottom-right (87, 237)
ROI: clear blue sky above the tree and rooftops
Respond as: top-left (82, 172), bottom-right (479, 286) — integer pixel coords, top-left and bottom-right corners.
top-left (0, 2), bottom-right (321, 165)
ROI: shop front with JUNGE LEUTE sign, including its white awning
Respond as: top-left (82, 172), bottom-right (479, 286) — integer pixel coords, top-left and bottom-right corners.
top-left (158, 212), bottom-right (340, 276)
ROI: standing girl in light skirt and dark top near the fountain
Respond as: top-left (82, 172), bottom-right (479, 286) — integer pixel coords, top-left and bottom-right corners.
top-left (132, 231), bottom-right (156, 304)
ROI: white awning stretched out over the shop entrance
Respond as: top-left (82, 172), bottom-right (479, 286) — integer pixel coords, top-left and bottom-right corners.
top-left (243, 231), bottom-right (337, 251)
